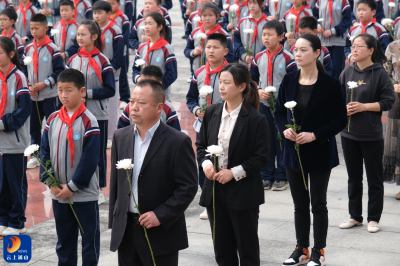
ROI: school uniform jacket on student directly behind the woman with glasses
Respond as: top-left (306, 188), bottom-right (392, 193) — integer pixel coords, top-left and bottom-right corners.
top-left (344, 22), bottom-right (390, 59)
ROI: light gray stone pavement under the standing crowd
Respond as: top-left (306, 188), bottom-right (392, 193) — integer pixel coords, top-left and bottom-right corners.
top-left (0, 0), bottom-right (400, 266)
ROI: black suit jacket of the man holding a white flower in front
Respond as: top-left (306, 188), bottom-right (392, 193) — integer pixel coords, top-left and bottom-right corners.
top-left (108, 123), bottom-right (198, 256)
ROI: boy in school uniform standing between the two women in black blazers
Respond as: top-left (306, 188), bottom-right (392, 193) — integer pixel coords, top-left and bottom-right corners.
top-left (250, 20), bottom-right (297, 191)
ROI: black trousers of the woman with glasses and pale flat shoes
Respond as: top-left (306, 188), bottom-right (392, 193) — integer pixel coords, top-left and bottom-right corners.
top-left (342, 137), bottom-right (384, 222)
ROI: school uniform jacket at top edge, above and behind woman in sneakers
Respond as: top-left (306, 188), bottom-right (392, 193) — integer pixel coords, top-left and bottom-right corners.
top-left (313, 0), bottom-right (352, 47)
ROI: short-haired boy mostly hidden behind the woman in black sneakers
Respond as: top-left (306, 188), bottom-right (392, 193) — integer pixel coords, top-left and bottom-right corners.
top-left (290, 17), bottom-right (333, 76)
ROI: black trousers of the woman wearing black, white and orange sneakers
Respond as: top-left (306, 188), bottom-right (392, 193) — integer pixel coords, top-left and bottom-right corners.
top-left (286, 168), bottom-right (331, 249)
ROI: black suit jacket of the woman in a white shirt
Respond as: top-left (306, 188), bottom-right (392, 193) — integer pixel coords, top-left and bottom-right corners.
top-left (196, 101), bottom-right (270, 210)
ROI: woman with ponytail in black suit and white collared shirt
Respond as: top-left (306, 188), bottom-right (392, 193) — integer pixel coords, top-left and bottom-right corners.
top-left (196, 64), bottom-right (270, 266)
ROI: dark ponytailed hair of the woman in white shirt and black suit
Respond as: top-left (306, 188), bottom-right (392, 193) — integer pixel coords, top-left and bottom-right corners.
top-left (219, 64), bottom-right (260, 110)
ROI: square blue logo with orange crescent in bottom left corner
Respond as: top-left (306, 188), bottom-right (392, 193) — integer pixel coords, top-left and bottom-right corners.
top-left (3, 235), bottom-right (32, 263)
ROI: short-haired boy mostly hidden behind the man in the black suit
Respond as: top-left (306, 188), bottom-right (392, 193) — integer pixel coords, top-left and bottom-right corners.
top-left (118, 65), bottom-right (181, 131)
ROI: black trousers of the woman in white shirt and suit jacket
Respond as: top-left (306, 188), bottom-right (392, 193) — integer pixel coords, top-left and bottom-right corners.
top-left (207, 181), bottom-right (260, 266)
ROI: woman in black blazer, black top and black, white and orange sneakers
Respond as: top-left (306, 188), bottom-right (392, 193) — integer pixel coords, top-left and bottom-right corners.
top-left (275, 34), bottom-right (347, 266)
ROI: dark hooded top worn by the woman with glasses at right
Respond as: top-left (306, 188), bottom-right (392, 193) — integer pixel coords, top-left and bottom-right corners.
top-left (339, 63), bottom-right (395, 141)
